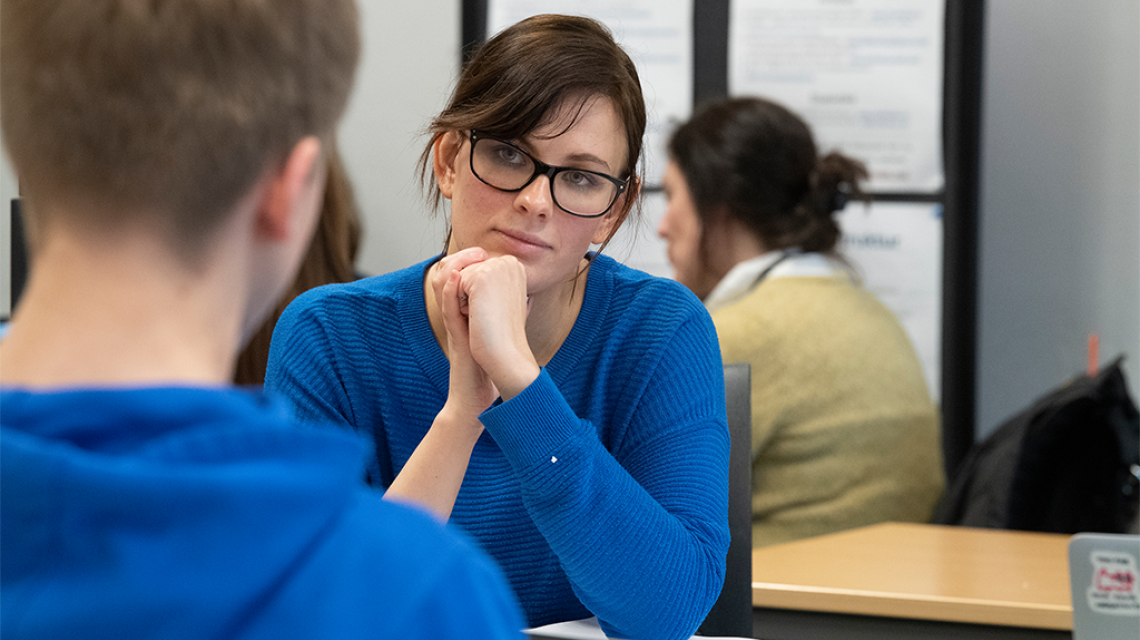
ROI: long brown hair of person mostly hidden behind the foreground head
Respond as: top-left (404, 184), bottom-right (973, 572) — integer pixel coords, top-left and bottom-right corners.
top-left (234, 152), bottom-right (361, 384)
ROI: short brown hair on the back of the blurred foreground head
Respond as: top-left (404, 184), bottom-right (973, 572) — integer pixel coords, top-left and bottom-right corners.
top-left (0, 0), bottom-right (359, 260)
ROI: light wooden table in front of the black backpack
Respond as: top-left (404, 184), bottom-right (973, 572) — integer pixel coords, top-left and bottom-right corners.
top-left (752, 524), bottom-right (1073, 640)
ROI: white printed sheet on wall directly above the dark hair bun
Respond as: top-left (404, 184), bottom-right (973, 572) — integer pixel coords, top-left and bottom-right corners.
top-left (728, 0), bottom-right (945, 193)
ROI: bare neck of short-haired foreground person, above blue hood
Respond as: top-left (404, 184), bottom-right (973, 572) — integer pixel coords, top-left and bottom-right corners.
top-left (0, 227), bottom-right (242, 387)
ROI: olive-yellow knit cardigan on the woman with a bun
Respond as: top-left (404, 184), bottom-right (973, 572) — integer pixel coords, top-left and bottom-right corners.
top-left (713, 271), bottom-right (945, 546)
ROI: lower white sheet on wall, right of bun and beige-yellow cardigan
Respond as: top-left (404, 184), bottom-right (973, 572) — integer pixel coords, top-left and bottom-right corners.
top-left (837, 202), bottom-right (943, 400)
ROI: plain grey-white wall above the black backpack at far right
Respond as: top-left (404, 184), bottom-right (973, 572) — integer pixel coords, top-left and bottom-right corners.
top-left (977, 0), bottom-right (1140, 435)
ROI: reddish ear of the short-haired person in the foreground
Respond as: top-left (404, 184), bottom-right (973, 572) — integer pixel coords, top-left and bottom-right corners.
top-left (257, 136), bottom-right (325, 241)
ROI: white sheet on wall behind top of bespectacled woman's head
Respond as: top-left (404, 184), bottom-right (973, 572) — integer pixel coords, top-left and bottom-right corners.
top-left (487, 0), bottom-right (693, 185)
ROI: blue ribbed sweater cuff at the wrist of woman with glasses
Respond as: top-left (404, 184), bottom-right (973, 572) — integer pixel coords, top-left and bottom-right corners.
top-left (479, 367), bottom-right (581, 470)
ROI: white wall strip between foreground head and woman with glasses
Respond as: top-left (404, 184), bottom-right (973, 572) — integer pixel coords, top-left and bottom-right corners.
top-left (340, 0), bottom-right (461, 274)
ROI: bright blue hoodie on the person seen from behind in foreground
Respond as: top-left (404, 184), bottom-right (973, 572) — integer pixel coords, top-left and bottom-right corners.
top-left (0, 388), bottom-right (523, 639)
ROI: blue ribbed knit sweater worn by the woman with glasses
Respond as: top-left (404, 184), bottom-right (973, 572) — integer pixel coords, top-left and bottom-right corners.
top-left (266, 256), bottom-right (728, 640)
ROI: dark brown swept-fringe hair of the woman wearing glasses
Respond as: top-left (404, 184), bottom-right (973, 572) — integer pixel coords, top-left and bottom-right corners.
top-left (420, 15), bottom-right (645, 244)
